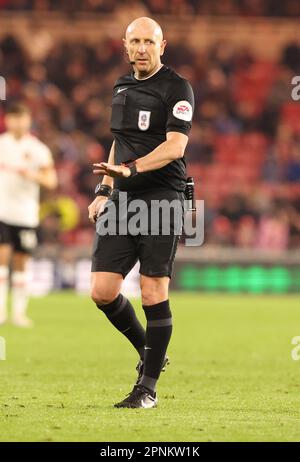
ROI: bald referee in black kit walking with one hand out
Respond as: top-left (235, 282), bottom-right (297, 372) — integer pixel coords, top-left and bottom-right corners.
top-left (89, 17), bottom-right (194, 408)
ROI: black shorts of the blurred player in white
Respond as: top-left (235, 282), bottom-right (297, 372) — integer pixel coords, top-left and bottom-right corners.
top-left (0, 221), bottom-right (37, 254)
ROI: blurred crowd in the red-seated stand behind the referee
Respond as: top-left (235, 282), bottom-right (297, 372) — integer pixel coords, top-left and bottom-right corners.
top-left (0, 0), bottom-right (300, 250)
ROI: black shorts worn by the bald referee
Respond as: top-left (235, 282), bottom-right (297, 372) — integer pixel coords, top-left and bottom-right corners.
top-left (92, 189), bottom-right (184, 278)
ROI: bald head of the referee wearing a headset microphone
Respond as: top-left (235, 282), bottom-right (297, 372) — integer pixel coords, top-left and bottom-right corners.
top-left (124, 23), bottom-right (166, 77)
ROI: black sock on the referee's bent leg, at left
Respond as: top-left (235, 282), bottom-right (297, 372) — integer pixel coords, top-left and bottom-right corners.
top-left (97, 294), bottom-right (146, 359)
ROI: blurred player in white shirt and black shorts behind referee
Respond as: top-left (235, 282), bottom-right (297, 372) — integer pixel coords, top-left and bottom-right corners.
top-left (0, 104), bottom-right (57, 327)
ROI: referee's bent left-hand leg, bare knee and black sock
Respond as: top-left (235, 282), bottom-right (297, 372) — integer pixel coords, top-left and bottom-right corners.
top-left (91, 271), bottom-right (146, 360)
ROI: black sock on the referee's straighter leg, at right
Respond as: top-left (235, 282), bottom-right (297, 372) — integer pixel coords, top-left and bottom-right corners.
top-left (139, 300), bottom-right (172, 391)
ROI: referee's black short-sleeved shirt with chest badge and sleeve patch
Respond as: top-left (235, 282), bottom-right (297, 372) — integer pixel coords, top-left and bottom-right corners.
top-left (111, 66), bottom-right (194, 191)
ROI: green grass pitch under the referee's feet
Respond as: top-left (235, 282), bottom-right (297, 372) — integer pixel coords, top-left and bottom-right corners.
top-left (0, 293), bottom-right (300, 442)
